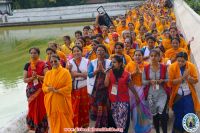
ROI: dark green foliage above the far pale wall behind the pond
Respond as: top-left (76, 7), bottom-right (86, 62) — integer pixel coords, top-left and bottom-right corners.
top-left (12, 0), bottom-right (133, 9)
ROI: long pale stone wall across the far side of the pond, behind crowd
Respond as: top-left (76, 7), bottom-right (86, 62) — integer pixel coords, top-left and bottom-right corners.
top-left (0, 1), bottom-right (143, 26)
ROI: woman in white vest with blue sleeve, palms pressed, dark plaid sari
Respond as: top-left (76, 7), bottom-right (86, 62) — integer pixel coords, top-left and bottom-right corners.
top-left (87, 45), bottom-right (111, 128)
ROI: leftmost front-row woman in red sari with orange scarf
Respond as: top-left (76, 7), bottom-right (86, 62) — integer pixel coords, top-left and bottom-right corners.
top-left (24, 48), bottom-right (48, 133)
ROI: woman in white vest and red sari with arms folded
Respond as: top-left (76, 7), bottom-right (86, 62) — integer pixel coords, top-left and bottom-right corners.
top-left (69, 46), bottom-right (89, 127)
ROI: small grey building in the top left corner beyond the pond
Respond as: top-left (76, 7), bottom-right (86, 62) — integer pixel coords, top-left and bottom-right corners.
top-left (0, 0), bottom-right (12, 15)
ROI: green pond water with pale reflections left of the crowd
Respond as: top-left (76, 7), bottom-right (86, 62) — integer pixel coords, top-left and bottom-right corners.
top-left (0, 23), bottom-right (90, 128)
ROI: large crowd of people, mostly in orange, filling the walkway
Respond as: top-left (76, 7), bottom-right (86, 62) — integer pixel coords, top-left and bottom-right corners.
top-left (24, 0), bottom-right (200, 133)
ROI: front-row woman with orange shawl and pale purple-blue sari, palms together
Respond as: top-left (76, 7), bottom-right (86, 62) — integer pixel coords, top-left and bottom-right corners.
top-left (125, 50), bottom-right (152, 133)
